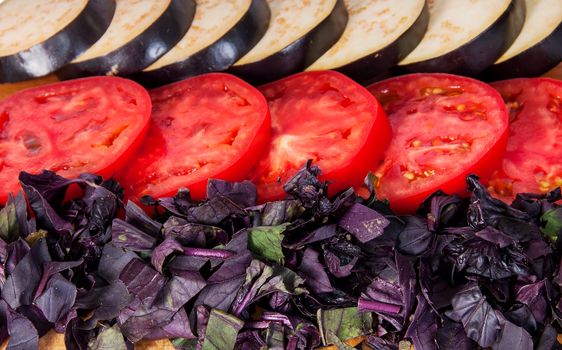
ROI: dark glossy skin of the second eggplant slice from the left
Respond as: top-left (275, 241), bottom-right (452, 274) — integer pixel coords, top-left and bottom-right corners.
top-left (57, 0), bottom-right (195, 79)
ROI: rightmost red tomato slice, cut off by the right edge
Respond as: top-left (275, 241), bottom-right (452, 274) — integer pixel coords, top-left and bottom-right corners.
top-left (488, 78), bottom-right (562, 201)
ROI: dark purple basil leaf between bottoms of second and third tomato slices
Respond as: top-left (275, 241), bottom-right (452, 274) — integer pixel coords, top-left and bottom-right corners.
top-left (207, 179), bottom-right (257, 208)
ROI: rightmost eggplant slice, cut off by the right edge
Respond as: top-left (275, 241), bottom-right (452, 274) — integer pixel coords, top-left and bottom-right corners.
top-left (484, 0), bottom-right (562, 80)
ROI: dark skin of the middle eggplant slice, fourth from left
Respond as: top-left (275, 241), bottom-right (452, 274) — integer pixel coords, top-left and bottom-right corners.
top-left (228, 0), bottom-right (348, 85)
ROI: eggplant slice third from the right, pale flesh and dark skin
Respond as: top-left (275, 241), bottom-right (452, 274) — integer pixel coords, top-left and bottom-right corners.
top-left (307, 0), bottom-right (429, 81)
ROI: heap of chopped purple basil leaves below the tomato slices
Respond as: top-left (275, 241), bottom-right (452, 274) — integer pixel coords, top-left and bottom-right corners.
top-left (0, 164), bottom-right (562, 349)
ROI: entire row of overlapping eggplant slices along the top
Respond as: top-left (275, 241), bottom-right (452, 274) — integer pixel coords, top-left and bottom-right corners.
top-left (0, 0), bottom-right (562, 86)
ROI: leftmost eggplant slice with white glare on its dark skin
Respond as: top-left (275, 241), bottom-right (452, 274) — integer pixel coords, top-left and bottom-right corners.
top-left (0, 0), bottom-right (115, 83)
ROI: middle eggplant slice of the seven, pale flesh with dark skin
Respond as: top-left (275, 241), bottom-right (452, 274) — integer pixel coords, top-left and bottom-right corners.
top-left (229, 0), bottom-right (348, 84)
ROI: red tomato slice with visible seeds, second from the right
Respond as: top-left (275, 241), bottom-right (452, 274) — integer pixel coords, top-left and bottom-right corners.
top-left (368, 74), bottom-right (508, 212)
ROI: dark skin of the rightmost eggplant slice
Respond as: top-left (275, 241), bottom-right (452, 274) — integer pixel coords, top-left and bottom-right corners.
top-left (481, 23), bottom-right (562, 81)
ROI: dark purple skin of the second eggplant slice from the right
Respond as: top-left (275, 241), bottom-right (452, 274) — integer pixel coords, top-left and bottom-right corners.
top-left (393, 0), bottom-right (526, 77)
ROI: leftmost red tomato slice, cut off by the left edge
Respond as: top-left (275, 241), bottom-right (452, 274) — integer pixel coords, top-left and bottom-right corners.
top-left (0, 77), bottom-right (151, 202)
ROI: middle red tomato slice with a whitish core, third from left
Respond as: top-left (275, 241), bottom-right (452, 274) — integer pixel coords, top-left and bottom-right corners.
top-left (252, 71), bottom-right (390, 202)
